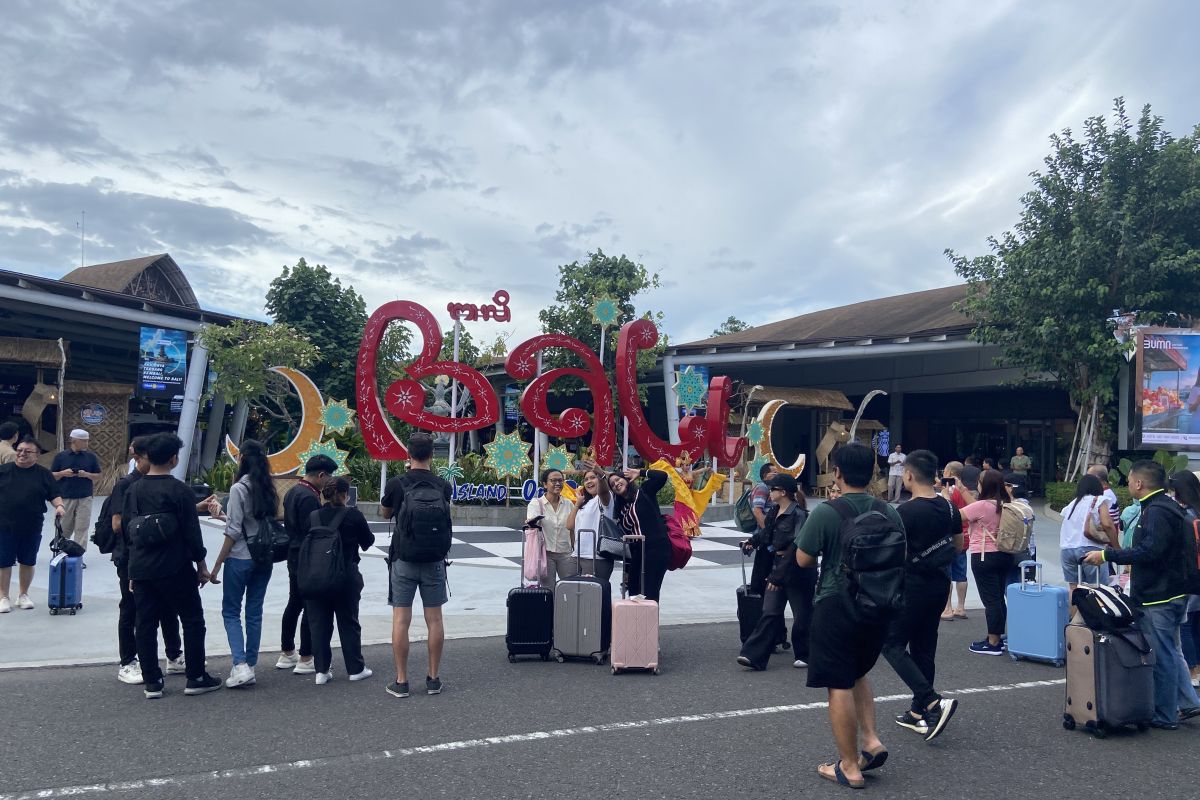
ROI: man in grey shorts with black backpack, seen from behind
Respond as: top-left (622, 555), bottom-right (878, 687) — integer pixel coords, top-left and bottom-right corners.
top-left (379, 433), bottom-right (452, 697)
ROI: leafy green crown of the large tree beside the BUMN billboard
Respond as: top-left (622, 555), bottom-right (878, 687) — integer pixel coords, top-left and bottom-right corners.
top-left (947, 98), bottom-right (1200, 405)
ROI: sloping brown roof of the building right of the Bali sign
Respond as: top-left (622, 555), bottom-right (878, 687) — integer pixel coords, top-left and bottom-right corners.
top-left (674, 284), bottom-right (973, 351)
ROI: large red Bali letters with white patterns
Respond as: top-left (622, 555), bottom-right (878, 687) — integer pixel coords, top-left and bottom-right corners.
top-left (355, 299), bottom-right (746, 467)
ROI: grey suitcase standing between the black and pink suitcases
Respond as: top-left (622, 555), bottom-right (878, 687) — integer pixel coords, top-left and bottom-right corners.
top-left (553, 530), bottom-right (612, 664)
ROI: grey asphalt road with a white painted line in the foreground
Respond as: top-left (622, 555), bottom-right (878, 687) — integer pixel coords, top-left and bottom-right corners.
top-left (0, 619), bottom-right (1200, 800)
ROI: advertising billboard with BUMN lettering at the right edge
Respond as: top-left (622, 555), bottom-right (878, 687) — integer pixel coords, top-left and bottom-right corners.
top-left (1134, 327), bottom-right (1200, 451)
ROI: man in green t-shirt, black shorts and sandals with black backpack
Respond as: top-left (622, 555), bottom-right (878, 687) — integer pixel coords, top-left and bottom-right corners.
top-left (796, 443), bottom-right (907, 788)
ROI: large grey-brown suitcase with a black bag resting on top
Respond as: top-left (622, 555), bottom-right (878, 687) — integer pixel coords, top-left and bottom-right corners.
top-left (1062, 616), bottom-right (1156, 739)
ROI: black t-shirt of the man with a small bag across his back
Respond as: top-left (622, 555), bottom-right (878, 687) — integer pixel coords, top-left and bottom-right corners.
top-left (121, 475), bottom-right (206, 581)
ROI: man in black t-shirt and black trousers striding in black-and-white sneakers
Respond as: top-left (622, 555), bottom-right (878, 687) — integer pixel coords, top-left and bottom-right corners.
top-left (883, 450), bottom-right (962, 741)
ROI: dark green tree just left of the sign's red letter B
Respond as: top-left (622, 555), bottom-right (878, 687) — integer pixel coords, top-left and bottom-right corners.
top-left (266, 258), bottom-right (367, 404)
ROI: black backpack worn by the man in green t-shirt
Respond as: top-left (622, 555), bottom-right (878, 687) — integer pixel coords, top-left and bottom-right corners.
top-left (830, 499), bottom-right (908, 625)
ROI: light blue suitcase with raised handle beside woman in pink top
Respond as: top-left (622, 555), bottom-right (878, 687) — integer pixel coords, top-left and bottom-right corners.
top-left (1006, 561), bottom-right (1070, 667)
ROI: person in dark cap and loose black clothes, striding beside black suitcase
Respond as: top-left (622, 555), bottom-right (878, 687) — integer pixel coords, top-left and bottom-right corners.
top-left (738, 473), bottom-right (817, 670)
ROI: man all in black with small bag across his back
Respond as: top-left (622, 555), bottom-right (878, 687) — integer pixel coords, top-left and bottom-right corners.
top-left (121, 433), bottom-right (221, 699)
